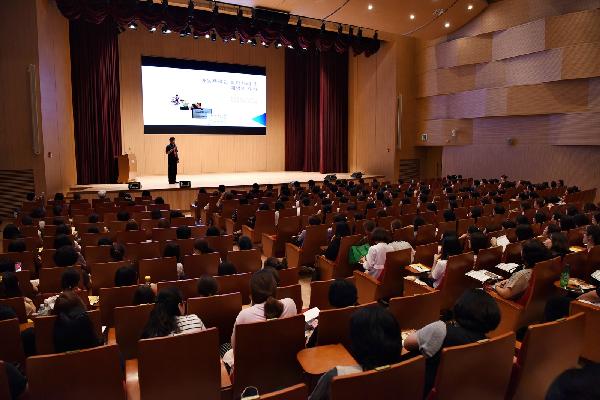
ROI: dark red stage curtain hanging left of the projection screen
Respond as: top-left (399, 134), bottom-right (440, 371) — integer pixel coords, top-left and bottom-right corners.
top-left (69, 19), bottom-right (121, 185)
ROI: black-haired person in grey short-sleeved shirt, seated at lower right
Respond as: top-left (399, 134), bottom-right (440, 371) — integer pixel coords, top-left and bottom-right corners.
top-left (404, 289), bottom-right (500, 397)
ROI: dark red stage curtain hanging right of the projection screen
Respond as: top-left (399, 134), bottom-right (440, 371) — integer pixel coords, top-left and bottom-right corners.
top-left (285, 50), bottom-right (348, 173)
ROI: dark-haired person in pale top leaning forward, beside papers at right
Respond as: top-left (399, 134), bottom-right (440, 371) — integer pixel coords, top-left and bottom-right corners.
top-left (492, 240), bottom-right (552, 300)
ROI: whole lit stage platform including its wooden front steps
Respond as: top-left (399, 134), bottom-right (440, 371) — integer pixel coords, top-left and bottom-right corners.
top-left (70, 171), bottom-right (383, 210)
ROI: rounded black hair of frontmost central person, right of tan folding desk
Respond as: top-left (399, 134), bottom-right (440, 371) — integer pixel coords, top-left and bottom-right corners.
top-left (350, 305), bottom-right (401, 370)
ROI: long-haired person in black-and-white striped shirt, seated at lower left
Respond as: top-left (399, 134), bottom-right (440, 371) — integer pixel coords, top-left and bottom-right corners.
top-left (142, 287), bottom-right (206, 339)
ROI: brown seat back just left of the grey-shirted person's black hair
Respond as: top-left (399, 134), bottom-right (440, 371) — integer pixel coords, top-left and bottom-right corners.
top-left (389, 290), bottom-right (442, 331)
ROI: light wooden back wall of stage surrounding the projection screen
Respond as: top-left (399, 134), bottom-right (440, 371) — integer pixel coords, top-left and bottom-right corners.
top-left (119, 30), bottom-right (285, 175)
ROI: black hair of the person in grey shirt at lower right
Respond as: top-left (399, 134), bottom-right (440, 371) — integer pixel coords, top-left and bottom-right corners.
top-left (453, 289), bottom-right (500, 334)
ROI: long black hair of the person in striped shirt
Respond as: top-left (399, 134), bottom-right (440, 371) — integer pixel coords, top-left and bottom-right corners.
top-left (142, 287), bottom-right (183, 339)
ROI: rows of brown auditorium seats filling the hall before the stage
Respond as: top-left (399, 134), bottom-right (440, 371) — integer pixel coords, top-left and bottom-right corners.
top-left (0, 176), bottom-right (600, 399)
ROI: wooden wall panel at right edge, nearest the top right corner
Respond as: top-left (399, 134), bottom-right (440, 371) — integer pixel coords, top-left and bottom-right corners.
top-left (546, 9), bottom-right (600, 48)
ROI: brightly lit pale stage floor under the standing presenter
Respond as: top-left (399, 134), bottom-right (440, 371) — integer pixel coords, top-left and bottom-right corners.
top-left (71, 171), bottom-right (383, 194)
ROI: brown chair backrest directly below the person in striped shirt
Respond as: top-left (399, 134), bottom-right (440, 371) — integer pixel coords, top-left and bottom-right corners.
top-left (138, 328), bottom-right (221, 400)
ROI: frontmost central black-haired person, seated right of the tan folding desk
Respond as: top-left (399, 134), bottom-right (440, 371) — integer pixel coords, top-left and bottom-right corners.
top-left (309, 305), bottom-right (401, 400)
